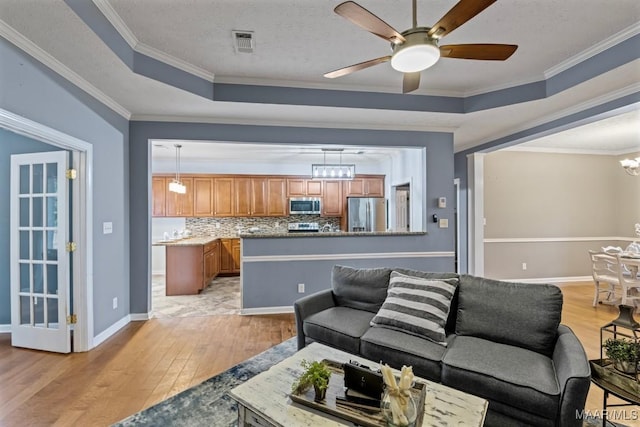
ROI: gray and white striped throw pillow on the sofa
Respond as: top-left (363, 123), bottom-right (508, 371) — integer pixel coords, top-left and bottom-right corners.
top-left (370, 271), bottom-right (458, 346)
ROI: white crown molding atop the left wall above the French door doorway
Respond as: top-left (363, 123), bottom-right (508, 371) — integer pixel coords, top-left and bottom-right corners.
top-left (0, 20), bottom-right (131, 120)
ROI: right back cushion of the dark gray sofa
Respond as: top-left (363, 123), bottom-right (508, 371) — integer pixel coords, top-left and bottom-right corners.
top-left (456, 275), bottom-right (562, 357)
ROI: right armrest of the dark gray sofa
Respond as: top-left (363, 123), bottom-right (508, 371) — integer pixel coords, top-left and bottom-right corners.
top-left (553, 325), bottom-right (591, 427)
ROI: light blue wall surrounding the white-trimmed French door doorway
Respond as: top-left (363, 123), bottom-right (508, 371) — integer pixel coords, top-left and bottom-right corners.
top-left (0, 38), bottom-right (129, 336)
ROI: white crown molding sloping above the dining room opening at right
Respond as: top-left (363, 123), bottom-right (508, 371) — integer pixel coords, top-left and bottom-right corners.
top-left (454, 83), bottom-right (640, 154)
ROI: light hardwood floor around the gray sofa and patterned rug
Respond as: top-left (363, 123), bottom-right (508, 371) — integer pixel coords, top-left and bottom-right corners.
top-left (0, 283), bottom-right (640, 426)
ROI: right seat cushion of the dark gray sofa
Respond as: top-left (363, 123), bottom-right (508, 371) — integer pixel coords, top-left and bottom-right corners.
top-left (442, 338), bottom-right (560, 420)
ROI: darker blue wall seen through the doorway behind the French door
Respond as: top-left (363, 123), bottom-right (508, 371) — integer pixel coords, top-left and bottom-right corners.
top-left (0, 129), bottom-right (60, 325)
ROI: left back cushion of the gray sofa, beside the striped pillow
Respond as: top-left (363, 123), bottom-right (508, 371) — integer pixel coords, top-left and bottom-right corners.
top-left (331, 265), bottom-right (391, 313)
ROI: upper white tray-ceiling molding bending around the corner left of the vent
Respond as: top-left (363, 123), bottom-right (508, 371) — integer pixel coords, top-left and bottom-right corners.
top-left (93, 0), bottom-right (214, 82)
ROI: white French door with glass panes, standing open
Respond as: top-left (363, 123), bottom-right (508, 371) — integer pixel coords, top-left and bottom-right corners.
top-left (10, 151), bottom-right (71, 353)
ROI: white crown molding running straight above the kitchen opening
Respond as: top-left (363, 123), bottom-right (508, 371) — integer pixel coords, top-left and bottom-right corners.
top-left (131, 114), bottom-right (457, 133)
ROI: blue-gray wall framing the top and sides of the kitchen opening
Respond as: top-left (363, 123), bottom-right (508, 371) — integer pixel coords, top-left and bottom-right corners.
top-left (129, 122), bottom-right (454, 313)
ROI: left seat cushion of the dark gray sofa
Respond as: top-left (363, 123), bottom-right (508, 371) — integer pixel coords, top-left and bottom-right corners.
top-left (303, 307), bottom-right (373, 354)
